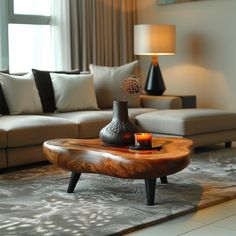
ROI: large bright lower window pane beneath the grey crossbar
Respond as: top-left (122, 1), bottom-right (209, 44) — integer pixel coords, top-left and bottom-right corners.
top-left (8, 24), bottom-right (53, 72)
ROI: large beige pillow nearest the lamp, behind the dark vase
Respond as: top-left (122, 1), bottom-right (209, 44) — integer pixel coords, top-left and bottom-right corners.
top-left (89, 61), bottom-right (140, 108)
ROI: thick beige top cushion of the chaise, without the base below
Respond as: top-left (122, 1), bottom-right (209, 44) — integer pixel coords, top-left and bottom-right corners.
top-left (136, 109), bottom-right (236, 136)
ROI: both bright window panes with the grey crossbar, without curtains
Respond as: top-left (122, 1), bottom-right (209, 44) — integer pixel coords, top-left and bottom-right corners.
top-left (8, 0), bottom-right (52, 73)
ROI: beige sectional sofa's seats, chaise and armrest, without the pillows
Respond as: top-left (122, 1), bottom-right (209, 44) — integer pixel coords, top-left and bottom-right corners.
top-left (0, 95), bottom-right (236, 169)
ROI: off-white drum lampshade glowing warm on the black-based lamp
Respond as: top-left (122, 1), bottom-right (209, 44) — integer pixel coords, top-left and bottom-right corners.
top-left (134, 25), bottom-right (176, 55)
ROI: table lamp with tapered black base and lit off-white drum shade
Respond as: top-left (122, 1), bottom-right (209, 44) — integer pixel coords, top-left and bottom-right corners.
top-left (134, 24), bottom-right (176, 95)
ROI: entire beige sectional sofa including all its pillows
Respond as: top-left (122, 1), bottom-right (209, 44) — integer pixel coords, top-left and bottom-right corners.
top-left (0, 62), bottom-right (236, 169)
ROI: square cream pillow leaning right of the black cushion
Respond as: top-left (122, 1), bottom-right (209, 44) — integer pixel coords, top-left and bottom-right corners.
top-left (50, 73), bottom-right (98, 112)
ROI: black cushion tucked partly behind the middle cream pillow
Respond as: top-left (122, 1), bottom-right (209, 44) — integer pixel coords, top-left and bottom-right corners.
top-left (32, 69), bottom-right (80, 112)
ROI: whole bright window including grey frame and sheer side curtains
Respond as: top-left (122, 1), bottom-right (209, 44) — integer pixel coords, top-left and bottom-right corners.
top-left (0, 0), bottom-right (71, 73)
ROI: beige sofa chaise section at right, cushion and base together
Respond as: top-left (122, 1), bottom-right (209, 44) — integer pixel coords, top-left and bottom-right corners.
top-left (136, 109), bottom-right (236, 147)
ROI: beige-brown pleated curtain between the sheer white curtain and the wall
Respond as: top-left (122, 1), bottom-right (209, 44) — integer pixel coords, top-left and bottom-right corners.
top-left (70, 0), bottom-right (136, 70)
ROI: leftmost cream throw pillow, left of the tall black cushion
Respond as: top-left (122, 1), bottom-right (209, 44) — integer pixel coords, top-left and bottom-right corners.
top-left (0, 73), bottom-right (43, 115)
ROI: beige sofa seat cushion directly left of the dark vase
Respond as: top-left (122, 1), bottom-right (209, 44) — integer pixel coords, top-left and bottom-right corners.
top-left (50, 110), bottom-right (112, 138)
